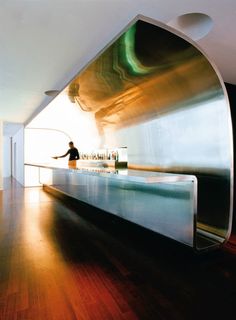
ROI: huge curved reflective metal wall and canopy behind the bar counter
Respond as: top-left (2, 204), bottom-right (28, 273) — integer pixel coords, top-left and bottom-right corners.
top-left (67, 18), bottom-right (233, 246)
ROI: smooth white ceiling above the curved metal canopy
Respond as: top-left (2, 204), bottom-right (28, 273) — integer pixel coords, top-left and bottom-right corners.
top-left (0, 0), bottom-right (236, 127)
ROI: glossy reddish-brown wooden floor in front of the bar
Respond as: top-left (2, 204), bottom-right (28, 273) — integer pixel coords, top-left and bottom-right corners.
top-left (0, 180), bottom-right (236, 320)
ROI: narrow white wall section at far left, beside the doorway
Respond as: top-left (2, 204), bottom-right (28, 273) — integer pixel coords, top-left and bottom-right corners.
top-left (12, 125), bottom-right (24, 185)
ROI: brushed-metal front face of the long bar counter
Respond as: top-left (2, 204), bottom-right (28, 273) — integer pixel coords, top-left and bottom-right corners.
top-left (47, 169), bottom-right (195, 247)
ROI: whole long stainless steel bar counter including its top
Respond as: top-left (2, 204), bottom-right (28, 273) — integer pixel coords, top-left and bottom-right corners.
top-left (26, 164), bottom-right (224, 250)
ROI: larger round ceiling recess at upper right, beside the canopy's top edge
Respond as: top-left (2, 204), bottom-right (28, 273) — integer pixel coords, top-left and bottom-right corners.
top-left (168, 13), bottom-right (213, 40)
